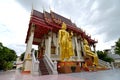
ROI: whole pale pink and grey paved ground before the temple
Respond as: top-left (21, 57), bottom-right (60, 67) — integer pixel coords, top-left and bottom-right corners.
top-left (0, 69), bottom-right (120, 80)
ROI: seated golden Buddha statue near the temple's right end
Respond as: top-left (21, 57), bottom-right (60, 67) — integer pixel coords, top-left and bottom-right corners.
top-left (84, 39), bottom-right (98, 66)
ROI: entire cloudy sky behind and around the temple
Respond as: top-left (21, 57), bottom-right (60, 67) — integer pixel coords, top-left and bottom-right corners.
top-left (0, 0), bottom-right (120, 55)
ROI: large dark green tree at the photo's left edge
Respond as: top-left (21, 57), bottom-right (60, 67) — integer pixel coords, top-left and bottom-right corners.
top-left (0, 42), bottom-right (17, 70)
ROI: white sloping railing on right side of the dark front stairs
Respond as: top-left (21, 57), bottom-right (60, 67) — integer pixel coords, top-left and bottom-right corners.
top-left (44, 54), bottom-right (58, 74)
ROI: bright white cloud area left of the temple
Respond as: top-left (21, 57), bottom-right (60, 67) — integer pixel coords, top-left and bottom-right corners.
top-left (0, 0), bottom-right (30, 54)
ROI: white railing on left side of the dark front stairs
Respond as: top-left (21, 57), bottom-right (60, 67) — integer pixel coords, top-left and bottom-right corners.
top-left (32, 49), bottom-right (39, 75)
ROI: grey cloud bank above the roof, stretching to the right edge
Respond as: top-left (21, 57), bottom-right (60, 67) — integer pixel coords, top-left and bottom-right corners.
top-left (17, 0), bottom-right (120, 49)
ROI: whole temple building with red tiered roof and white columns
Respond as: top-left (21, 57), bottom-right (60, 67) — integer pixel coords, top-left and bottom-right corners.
top-left (23, 10), bottom-right (109, 75)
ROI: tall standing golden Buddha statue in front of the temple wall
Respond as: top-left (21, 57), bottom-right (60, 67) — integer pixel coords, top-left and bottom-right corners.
top-left (58, 22), bottom-right (73, 61)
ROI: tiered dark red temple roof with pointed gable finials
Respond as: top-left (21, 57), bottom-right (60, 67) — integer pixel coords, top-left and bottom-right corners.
top-left (25, 10), bottom-right (97, 45)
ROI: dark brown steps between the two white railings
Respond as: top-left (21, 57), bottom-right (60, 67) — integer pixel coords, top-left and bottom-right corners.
top-left (39, 59), bottom-right (49, 75)
